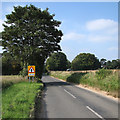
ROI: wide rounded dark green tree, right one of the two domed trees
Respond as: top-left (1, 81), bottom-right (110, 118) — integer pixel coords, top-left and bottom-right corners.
top-left (71, 53), bottom-right (100, 70)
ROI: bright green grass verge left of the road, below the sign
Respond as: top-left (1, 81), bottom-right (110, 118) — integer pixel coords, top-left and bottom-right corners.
top-left (2, 82), bottom-right (43, 118)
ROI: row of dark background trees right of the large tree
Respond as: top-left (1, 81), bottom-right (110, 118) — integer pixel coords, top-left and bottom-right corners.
top-left (46, 52), bottom-right (120, 71)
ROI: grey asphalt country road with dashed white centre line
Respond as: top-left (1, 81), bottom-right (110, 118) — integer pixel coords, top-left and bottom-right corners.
top-left (38, 76), bottom-right (118, 120)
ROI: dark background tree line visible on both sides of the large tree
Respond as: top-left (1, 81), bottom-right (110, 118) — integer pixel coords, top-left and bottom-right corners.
top-left (0, 52), bottom-right (120, 75)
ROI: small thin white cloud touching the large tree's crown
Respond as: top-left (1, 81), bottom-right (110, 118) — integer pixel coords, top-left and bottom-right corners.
top-left (63, 32), bottom-right (85, 41)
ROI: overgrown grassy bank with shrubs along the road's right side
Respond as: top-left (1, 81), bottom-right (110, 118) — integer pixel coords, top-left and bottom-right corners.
top-left (51, 69), bottom-right (120, 97)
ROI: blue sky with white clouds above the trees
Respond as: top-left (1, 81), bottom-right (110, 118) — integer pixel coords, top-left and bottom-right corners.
top-left (0, 2), bottom-right (118, 61)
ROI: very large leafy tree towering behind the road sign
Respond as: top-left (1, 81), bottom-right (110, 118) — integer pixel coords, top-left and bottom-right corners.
top-left (2, 5), bottom-right (63, 77)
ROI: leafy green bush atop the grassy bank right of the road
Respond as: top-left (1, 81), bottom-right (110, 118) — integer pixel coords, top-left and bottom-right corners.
top-left (96, 68), bottom-right (112, 80)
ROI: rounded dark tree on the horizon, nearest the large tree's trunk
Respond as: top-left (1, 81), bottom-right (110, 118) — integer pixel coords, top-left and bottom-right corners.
top-left (46, 52), bottom-right (69, 71)
